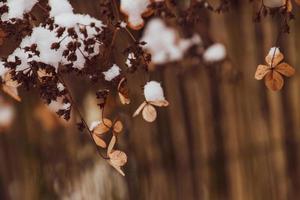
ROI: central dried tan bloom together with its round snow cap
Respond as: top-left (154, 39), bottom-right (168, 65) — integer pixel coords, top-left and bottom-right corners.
top-left (133, 81), bottom-right (169, 122)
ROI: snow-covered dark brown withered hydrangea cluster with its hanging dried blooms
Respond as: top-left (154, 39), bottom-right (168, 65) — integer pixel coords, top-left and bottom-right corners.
top-left (0, 0), bottom-right (298, 175)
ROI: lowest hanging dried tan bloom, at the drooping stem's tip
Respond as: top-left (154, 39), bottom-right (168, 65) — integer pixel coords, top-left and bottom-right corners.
top-left (107, 136), bottom-right (127, 176)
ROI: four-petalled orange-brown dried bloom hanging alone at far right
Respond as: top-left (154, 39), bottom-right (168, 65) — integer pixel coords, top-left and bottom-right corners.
top-left (255, 47), bottom-right (295, 91)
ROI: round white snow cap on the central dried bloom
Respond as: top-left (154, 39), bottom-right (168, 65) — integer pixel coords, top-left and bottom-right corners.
top-left (144, 81), bottom-right (165, 101)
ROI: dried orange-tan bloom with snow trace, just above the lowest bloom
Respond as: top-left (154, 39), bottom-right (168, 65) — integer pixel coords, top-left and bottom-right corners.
top-left (90, 118), bottom-right (123, 148)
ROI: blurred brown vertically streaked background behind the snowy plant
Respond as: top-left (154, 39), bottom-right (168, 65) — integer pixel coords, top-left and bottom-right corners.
top-left (0, 0), bottom-right (300, 200)
